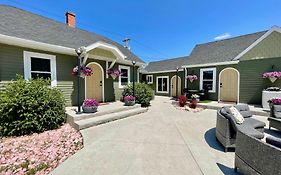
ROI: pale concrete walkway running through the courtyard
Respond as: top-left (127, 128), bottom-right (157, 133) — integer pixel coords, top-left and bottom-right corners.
top-left (51, 97), bottom-right (266, 175)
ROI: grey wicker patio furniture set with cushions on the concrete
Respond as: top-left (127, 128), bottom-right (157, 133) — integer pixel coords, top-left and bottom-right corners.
top-left (216, 104), bottom-right (281, 175)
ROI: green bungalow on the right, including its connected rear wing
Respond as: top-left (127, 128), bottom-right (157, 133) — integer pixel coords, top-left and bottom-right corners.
top-left (142, 26), bottom-right (281, 104)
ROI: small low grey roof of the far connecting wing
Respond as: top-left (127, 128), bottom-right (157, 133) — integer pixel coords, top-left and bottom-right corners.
top-left (144, 56), bottom-right (188, 73)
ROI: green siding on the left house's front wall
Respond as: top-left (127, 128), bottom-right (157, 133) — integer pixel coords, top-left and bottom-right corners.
top-left (0, 44), bottom-right (138, 106)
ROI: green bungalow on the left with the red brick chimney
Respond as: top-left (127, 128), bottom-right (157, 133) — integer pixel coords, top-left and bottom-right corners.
top-left (0, 5), bottom-right (144, 106)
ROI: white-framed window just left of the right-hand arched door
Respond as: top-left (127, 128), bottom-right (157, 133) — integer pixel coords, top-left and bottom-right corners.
top-left (200, 68), bottom-right (216, 93)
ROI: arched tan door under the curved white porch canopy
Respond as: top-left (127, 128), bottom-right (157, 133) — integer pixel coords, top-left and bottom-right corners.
top-left (85, 63), bottom-right (103, 102)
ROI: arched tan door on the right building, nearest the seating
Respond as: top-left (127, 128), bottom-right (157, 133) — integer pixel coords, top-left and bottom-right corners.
top-left (220, 68), bottom-right (239, 102)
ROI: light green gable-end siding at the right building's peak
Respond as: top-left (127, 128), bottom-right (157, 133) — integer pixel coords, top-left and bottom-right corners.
top-left (240, 32), bottom-right (281, 61)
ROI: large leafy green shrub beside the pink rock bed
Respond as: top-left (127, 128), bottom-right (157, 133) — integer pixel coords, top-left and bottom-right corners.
top-left (0, 76), bottom-right (65, 136)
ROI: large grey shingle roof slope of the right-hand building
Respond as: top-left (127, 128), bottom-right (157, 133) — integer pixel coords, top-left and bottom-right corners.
top-left (185, 31), bottom-right (267, 66)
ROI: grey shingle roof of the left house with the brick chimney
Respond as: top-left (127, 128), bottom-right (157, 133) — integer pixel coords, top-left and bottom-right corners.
top-left (0, 5), bottom-right (143, 63)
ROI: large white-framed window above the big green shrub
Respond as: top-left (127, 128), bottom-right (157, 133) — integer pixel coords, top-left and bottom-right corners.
top-left (23, 51), bottom-right (57, 86)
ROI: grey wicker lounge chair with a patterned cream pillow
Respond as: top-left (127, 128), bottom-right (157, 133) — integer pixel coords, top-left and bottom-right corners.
top-left (216, 104), bottom-right (265, 152)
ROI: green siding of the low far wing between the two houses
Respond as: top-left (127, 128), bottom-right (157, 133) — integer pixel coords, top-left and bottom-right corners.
top-left (143, 71), bottom-right (185, 96)
